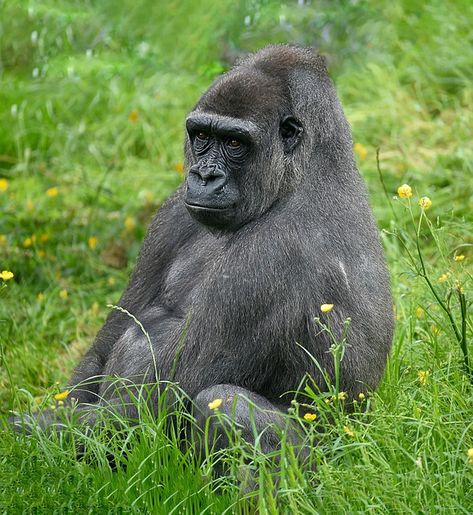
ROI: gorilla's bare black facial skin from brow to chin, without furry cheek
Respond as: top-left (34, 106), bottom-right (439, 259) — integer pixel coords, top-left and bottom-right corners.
top-left (185, 111), bottom-right (258, 229)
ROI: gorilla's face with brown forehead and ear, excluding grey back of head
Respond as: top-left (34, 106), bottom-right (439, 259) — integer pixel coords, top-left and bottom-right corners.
top-left (185, 68), bottom-right (302, 231)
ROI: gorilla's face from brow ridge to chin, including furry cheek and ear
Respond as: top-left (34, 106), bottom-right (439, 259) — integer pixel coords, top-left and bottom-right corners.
top-left (185, 111), bottom-right (302, 230)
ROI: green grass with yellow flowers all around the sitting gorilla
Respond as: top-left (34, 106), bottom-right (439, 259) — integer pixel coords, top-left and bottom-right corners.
top-left (0, 0), bottom-right (473, 513)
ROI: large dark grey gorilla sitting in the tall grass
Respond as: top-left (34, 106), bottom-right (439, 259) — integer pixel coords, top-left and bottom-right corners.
top-left (12, 45), bottom-right (393, 451)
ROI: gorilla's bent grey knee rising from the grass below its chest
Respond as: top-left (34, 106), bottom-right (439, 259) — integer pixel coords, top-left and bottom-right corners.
top-left (194, 384), bottom-right (301, 454)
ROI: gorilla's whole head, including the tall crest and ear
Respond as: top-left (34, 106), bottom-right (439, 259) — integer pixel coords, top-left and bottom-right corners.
top-left (185, 46), bottom-right (349, 231)
